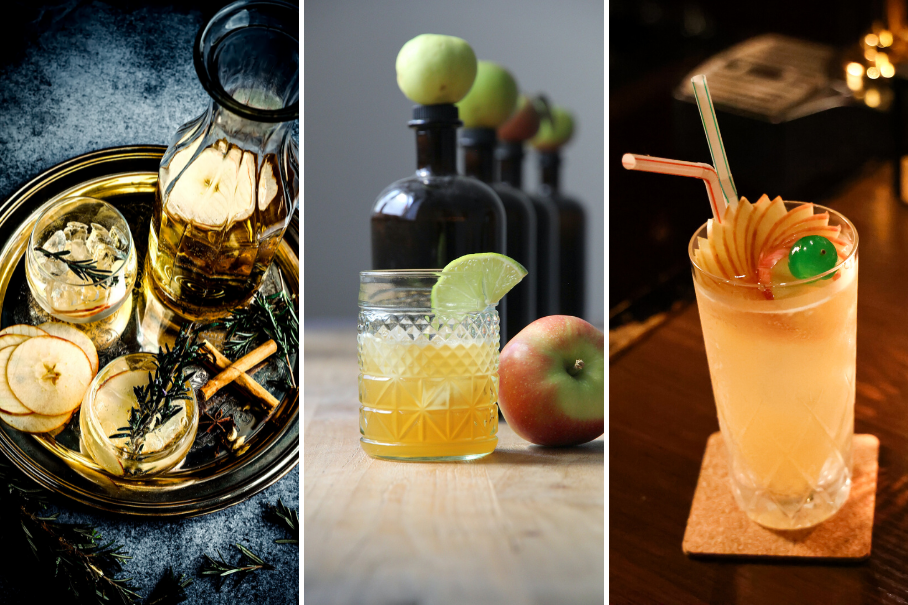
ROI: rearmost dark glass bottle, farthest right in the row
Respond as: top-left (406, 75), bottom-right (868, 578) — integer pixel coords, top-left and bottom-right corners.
top-left (539, 151), bottom-right (586, 317)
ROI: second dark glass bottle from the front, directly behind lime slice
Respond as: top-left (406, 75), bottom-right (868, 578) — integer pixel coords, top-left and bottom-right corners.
top-left (460, 128), bottom-right (537, 345)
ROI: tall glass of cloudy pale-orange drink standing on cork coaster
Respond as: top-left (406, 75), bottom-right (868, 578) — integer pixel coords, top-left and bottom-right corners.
top-left (688, 202), bottom-right (858, 529)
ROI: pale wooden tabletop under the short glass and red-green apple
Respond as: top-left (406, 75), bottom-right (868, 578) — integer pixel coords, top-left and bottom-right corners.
top-left (303, 325), bottom-right (605, 605)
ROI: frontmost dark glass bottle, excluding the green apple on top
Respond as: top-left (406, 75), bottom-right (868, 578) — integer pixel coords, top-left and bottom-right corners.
top-left (372, 104), bottom-right (506, 272)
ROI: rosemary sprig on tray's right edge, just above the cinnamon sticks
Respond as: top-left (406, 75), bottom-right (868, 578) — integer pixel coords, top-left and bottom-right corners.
top-left (216, 290), bottom-right (299, 388)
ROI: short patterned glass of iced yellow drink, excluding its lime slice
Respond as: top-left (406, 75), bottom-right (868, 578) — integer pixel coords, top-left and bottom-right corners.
top-left (357, 270), bottom-right (499, 460)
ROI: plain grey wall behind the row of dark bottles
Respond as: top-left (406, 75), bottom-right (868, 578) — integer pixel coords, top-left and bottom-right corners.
top-left (303, 0), bottom-right (605, 325)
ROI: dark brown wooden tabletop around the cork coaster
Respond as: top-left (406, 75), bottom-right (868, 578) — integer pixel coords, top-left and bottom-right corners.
top-left (609, 164), bottom-right (908, 605)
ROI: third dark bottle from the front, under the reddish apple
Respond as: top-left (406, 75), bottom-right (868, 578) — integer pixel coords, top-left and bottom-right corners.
top-left (495, 142), bottom-right (559, 319)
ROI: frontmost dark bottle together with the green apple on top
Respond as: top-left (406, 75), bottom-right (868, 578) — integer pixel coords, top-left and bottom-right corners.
top-left (371, 34), bottom-right (505, 270)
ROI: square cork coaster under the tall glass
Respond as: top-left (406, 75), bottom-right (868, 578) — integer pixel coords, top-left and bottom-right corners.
top-left (682, 433), bottom-right (880, 561)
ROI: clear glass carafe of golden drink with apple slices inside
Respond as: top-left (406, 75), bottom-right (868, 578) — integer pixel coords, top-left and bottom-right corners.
top-left (147, 0), bottom-right (299, 318)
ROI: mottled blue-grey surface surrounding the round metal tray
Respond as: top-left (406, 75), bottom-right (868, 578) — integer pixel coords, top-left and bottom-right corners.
top-left (0, 1), bottom-right (299, 605)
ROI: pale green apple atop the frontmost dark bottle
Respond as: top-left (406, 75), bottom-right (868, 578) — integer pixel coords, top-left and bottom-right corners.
top-left (395, 34), bottom-right (476, 105)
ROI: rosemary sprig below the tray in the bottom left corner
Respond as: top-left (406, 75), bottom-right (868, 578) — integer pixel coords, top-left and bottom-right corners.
top-left (0, 461), bottom-right (140, 605)
